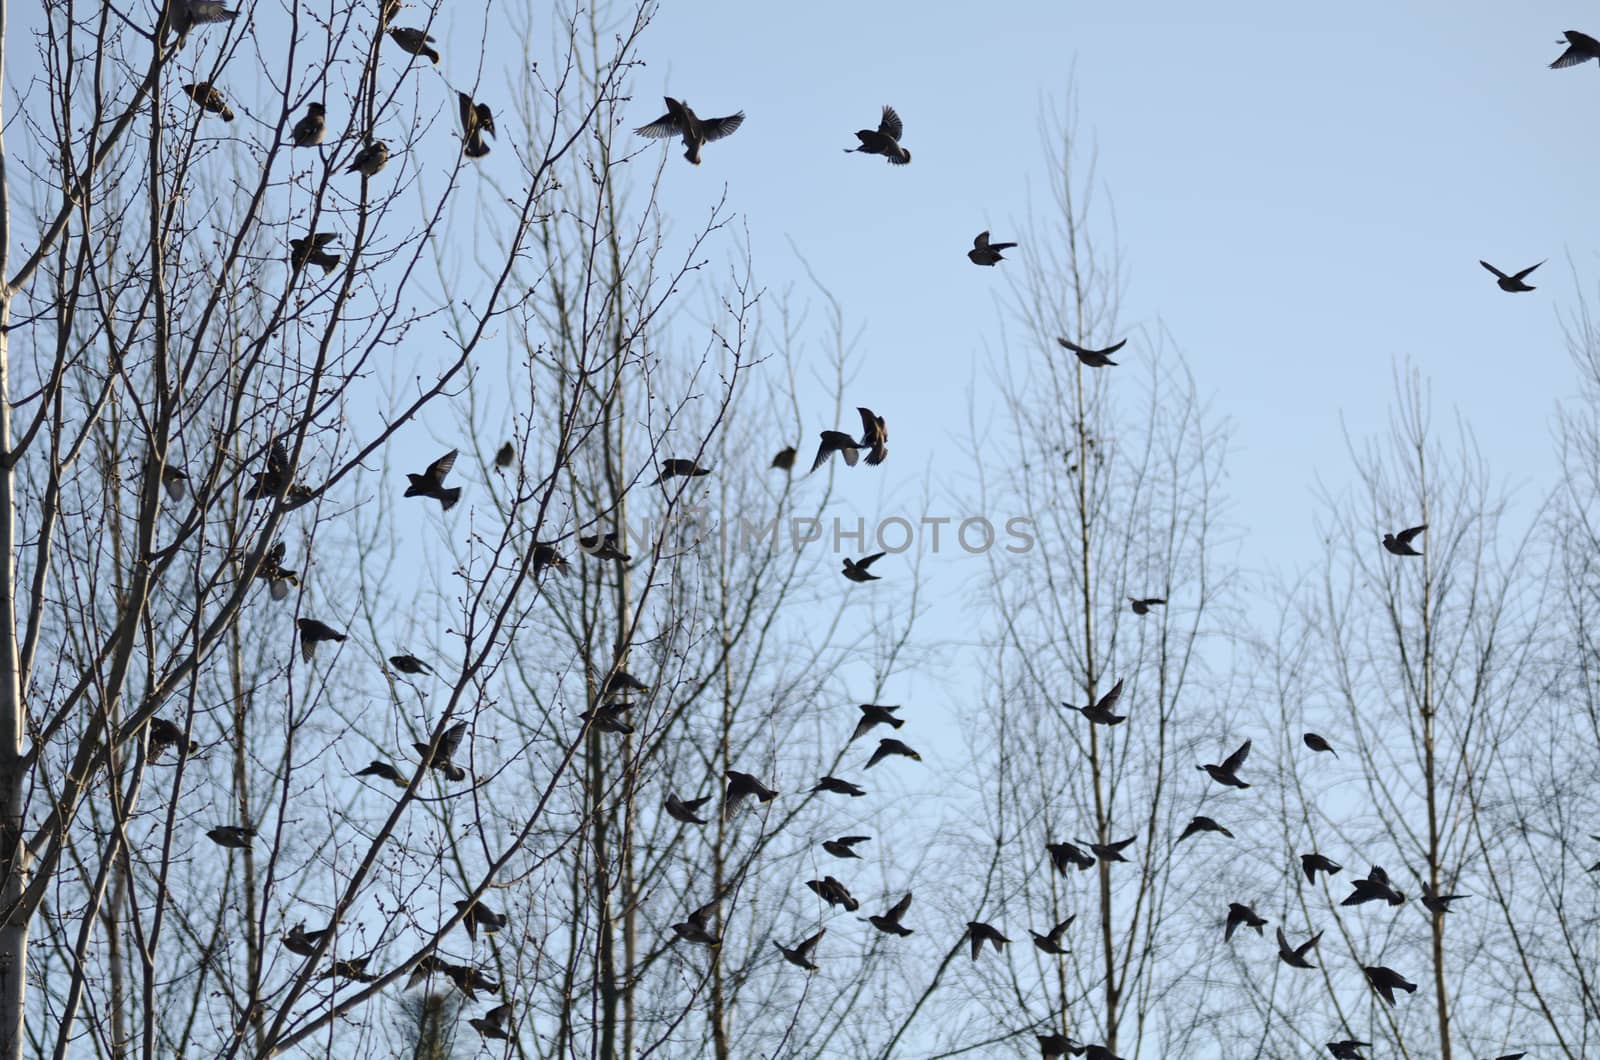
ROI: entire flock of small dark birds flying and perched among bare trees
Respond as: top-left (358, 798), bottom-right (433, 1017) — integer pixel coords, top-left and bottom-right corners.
top-left (131, 0), bottom-right (1600, 1060)
